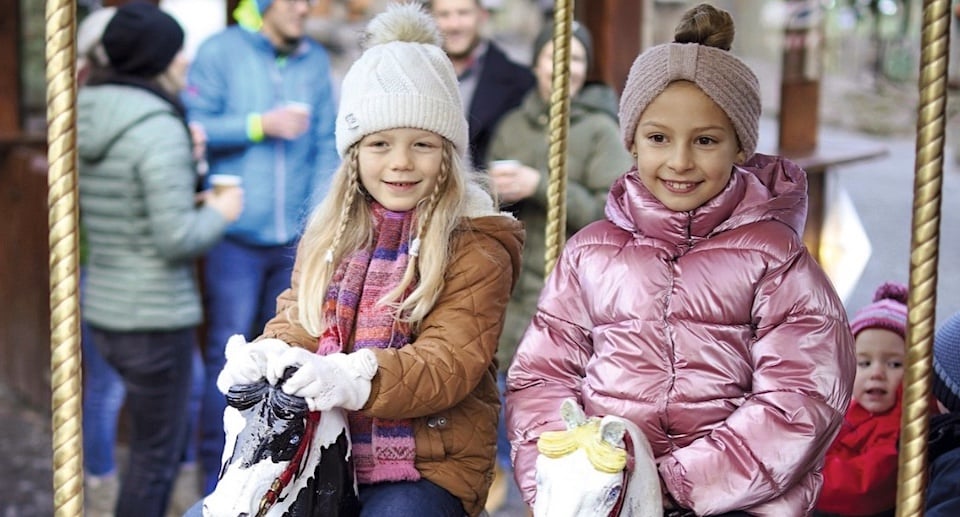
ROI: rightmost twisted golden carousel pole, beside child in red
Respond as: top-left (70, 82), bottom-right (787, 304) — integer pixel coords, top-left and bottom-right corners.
top-left (897, 0), bottom-right (950, 517)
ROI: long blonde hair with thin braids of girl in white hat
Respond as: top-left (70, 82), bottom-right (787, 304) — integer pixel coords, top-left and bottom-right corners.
top-left (296, 138), bottom-right (473, 336)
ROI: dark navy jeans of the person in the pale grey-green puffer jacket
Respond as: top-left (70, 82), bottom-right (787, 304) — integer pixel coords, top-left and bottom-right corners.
top-left (91, 327), bottom-right (197, 517)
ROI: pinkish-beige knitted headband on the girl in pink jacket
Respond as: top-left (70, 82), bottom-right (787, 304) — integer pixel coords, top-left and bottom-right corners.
top-left (620, 43), bottom-right (761, 158)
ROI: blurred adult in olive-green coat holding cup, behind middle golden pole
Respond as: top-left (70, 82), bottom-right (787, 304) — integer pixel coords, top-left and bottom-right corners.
top-left (488, 22), bottom-right (632, 510)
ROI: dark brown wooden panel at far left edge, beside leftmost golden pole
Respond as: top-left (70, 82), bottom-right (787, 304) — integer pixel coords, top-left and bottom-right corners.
top-left (0, 0), bottom-right (50, 408)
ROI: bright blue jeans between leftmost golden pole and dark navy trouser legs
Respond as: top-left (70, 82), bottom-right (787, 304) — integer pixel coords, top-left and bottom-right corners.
top-left (80, 269), bottom-right (125, 476)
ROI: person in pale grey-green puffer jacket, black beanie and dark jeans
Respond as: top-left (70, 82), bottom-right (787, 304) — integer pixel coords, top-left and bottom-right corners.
top-left (77, 2), bottom-right (243, 517)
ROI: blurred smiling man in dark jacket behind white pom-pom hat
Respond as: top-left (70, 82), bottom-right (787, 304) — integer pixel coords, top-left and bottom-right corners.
top-left (427, 0), bottom-right (535, 168)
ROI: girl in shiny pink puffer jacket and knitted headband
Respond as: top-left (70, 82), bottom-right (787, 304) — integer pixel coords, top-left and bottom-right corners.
top-left (506, 4), bottom-right (855, 517)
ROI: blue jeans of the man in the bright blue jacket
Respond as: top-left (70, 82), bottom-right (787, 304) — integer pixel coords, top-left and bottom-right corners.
top-left (199, 238), bottom-right (296, 494)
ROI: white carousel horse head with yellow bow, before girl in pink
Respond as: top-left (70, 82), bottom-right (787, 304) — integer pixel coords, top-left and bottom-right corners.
top-left (533, 399), bottom-right (663, 517)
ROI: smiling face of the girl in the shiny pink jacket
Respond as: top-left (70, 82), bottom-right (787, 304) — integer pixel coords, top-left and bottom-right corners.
top-left (632, 81), bottom-right (744, 212)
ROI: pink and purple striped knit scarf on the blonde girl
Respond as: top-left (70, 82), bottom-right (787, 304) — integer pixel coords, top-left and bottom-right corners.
top-left (317, 202), bottom-right (420, 484)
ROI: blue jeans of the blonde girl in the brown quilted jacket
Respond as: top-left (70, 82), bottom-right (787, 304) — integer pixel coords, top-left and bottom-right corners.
top-left (183, 479), bottom-right (465, 517)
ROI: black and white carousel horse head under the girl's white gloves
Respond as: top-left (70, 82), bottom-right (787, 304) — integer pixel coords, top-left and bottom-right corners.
top-left (203, 368), bottom-right (360, 517)
